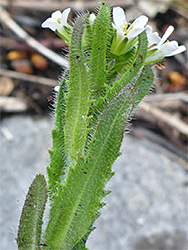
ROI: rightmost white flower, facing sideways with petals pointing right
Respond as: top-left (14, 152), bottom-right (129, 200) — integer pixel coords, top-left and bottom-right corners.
top-left (145, 26), bottom-right (186, 63)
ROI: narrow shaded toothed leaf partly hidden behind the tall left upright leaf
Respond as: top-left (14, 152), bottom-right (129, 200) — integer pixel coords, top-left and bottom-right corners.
top-left (47, 76), bottom-right (67, 198)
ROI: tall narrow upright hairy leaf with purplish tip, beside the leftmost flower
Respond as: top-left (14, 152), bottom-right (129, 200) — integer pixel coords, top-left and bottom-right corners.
top-left (64, 14), bottom-right (91, 166)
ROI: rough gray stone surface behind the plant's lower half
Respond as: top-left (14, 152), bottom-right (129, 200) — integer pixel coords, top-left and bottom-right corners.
top-left (0, 116), bottom-right (188, 250)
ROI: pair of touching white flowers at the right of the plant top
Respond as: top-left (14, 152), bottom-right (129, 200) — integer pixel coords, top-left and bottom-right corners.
top-left (111, 7), bottom-right (186, 61)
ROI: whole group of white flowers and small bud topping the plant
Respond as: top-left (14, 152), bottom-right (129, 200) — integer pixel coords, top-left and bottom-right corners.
top-left (42, 7), bottom-right (186, 64)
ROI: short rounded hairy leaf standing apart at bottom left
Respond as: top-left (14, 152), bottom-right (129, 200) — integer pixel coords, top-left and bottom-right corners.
top-left (16, 173), bottom-right (47, 250)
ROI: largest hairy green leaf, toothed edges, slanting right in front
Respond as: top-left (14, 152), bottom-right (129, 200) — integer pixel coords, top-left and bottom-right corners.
top-left (45, 90), bottom-right (134, 250)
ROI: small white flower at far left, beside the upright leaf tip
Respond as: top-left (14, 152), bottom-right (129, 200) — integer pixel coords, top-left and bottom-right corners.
top-left (41, 8), bottom-right (72, 42)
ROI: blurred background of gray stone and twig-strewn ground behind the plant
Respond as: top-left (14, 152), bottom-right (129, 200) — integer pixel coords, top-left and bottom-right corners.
top-left (0, 0), bottom-right (188, 250)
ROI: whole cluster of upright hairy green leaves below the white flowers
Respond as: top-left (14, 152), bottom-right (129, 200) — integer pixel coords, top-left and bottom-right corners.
top-left (17, 3), bottom-right (153, 250)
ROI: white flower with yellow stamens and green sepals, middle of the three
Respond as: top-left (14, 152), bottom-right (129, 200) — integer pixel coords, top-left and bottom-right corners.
top-left (111, 7), bottom-right (148, 55)
